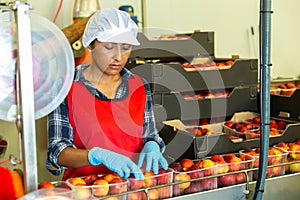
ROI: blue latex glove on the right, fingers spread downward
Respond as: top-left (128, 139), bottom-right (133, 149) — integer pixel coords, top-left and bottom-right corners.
top-left (138, 141), bottom-right (168, 174)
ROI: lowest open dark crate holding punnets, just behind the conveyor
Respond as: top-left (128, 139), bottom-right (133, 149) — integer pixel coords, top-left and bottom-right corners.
top-left (157, 112), bottom-right (300, 162)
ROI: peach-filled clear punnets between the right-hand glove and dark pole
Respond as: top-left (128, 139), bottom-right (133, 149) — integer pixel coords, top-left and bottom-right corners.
top-left (170, 153), bottom-right (254, 193)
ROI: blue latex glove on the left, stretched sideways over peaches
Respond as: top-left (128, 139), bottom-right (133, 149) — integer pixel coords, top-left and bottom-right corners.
top-left (88, 147), bottom-right (145, 179)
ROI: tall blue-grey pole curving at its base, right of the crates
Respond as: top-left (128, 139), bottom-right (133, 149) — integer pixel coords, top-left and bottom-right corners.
top-left (253, 0), bottom-right (272, 199)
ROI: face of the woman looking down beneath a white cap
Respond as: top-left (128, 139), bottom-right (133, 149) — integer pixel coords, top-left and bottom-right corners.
top-left (92, 40), bottom-right (132, 76)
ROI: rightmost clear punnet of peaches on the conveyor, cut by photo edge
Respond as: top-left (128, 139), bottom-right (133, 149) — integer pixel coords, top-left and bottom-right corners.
top-left (274, 139), bottom-right (300, 174)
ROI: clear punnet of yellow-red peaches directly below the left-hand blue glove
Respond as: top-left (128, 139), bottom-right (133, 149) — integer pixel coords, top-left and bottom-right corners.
top-left (66, 174), bottom-right (128, 200)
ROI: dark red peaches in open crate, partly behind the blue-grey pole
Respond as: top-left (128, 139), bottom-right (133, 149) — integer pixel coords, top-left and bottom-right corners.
top-left (224, 117), bottom-right (286, 140)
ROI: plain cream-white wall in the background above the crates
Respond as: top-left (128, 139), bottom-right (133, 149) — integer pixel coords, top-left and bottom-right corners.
top-left (28, 0), bottom-right (300, 78)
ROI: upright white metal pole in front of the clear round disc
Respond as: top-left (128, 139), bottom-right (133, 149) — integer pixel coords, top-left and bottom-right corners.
top-left (14, 1), bottom-right (38, 193)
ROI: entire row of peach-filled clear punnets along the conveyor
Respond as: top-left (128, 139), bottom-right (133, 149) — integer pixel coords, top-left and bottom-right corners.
top-left (39, 144), bottom-right (292, 200)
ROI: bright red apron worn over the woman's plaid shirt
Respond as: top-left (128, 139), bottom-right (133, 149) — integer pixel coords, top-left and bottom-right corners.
top-left (63, 76), bottom-right (146, 180)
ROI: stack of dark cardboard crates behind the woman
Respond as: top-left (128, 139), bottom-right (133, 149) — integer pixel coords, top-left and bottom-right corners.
top-left (126, 32), bottom-right (258, 160)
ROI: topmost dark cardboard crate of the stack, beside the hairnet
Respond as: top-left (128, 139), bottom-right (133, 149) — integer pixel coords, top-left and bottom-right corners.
top-left (129, 31), bottom-right (215, 60)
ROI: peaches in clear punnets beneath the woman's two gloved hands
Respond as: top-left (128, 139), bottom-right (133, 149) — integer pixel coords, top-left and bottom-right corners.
top-left (45, 169), bottom-right (173, 200)
